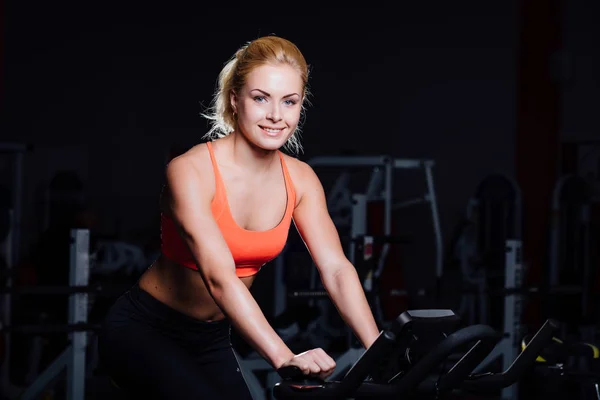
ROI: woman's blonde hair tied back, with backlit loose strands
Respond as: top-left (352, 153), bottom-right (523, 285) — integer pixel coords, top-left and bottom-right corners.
top-left (202, 36), bottom-right (309, 154)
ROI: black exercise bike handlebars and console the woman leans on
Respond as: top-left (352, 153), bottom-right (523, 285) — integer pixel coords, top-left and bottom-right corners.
top-left (273, 310), bottom-right (557, 400)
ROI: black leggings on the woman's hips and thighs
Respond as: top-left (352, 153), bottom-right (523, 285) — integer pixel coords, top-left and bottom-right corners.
top-left (99, 284), bottom-right (252, 400)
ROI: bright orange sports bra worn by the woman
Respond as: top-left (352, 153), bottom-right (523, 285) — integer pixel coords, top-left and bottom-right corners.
top-left (161, 142), bottom-right (296, 278)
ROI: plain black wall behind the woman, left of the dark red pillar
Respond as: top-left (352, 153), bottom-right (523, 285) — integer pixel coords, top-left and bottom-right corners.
top-left (2, 1), bottom-right (517, 284)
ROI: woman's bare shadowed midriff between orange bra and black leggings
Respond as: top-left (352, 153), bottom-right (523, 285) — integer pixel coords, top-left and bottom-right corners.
top-left (139, 255), bottom-right (254, 322)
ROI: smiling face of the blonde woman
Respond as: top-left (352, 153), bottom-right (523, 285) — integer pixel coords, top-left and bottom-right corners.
top-left (230, 64), bottom-right (303, 150)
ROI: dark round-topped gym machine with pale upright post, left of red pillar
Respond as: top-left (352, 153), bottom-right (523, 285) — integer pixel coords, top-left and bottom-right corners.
top-left (457, 174), bottom-right (524, 399)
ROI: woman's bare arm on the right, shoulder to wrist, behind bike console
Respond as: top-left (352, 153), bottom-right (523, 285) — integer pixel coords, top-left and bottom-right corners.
top-left (294, 163), bottom-right (379, 348)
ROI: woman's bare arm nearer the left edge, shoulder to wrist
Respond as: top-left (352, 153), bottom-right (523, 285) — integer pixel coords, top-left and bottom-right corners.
top-left (166, 156), bottom-right (294, 368)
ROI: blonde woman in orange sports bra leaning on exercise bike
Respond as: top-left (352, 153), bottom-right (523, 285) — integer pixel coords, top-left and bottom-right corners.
top-left (100, 36), bottom-right (379, 399)
